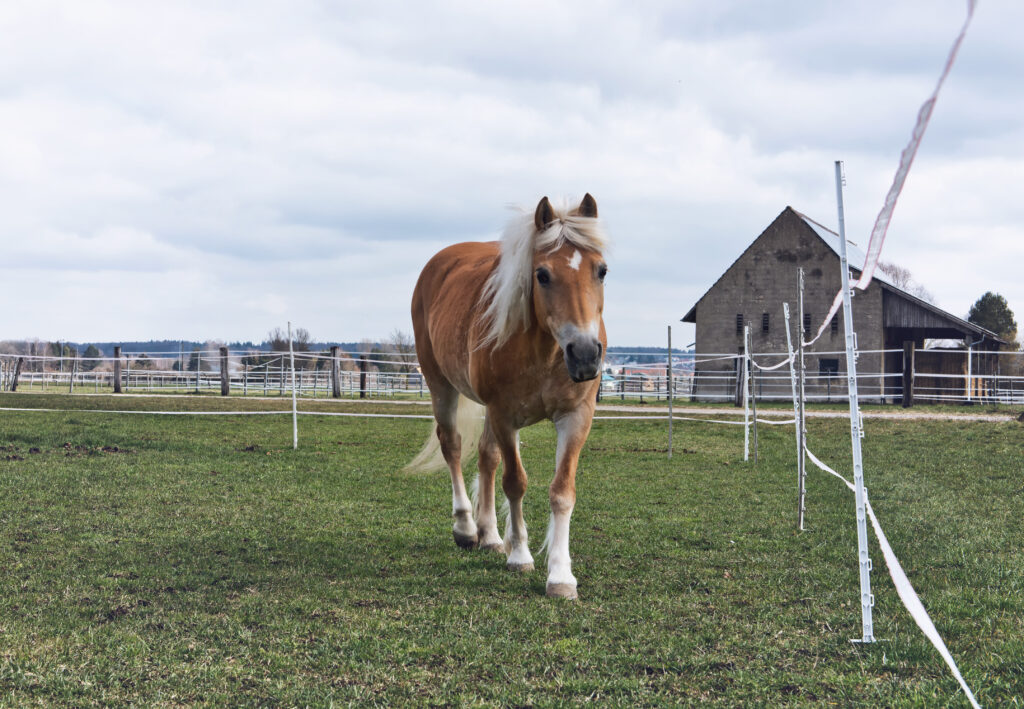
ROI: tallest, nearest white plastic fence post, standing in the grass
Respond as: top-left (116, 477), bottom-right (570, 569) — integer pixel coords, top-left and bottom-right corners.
top-left (836, 160), bottom-right (874, 642)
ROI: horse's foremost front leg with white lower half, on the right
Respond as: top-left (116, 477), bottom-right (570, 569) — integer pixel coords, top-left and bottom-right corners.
top-left (545, 409), bottom-right (594, 598)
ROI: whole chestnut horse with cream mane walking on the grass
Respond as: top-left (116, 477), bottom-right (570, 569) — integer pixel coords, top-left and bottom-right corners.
top-left (407, 195), bottom-right (607, 598)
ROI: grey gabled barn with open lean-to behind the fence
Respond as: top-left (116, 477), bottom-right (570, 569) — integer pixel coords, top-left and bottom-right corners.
top-left (682, 207), bottom-right (1002, 402)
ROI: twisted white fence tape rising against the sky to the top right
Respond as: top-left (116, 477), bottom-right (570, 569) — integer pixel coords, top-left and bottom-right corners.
top-left (804, 0), bottom-right (977, 347)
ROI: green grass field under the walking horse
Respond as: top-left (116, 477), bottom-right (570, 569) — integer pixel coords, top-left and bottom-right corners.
top-left (0, 394), bottom-right (1024, 706)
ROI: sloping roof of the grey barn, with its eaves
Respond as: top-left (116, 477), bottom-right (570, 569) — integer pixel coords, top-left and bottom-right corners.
top-left (682, 207), bottom-right (1002, 343)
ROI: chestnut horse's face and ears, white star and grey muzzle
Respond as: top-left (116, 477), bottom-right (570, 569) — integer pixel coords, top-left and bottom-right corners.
top-left (532, 195), bottom-right (608, 382)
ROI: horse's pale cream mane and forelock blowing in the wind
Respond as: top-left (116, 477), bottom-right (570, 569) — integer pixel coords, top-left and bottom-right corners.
top-left (480, 202), bottom-right (608, 347)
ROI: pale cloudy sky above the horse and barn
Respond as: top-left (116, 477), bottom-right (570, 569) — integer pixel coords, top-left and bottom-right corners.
top-left (0, 0), bottom-right (1024, 345)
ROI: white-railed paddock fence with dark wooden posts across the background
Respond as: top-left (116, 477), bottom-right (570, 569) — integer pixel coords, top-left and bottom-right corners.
top-left (0, 349), bottom-right (1024, 405)
